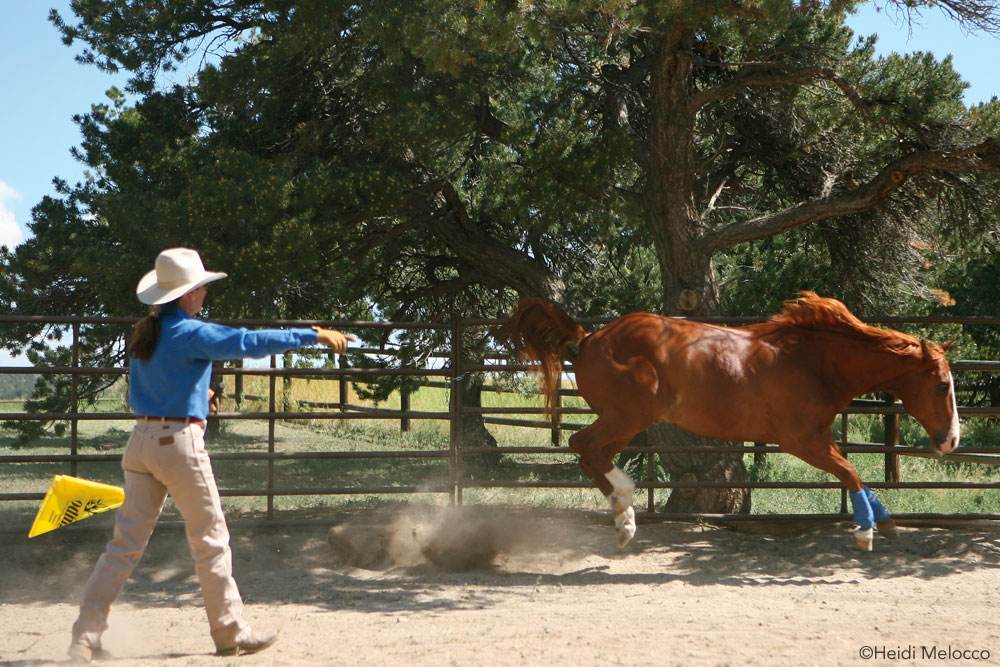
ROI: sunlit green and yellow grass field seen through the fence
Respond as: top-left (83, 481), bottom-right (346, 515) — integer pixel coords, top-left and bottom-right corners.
top-left (0, 377), bottom-right (1000, 527)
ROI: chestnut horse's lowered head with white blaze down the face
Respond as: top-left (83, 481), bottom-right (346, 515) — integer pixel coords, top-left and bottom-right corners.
top-left (893, 340), bottom-right (959, 455)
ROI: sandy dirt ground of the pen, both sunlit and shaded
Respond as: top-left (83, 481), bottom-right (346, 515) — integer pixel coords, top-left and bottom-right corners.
top-left (0, 507), bottom-right (1000, 667)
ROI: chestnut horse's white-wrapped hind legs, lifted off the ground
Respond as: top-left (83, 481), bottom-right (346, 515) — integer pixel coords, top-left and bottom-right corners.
top-left (569, 413), bottom-right (648, 547)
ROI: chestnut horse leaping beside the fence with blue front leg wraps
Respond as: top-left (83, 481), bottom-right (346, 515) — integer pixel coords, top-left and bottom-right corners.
top-left (501, 292), bottom-right (959, 550)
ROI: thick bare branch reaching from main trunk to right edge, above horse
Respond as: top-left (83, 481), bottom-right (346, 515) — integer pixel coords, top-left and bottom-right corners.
top-left (702, 139), bottom-right (1000, 252)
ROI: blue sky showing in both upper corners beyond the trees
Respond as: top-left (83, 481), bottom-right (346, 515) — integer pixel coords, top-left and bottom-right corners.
top-left (0, 0), bottom-right (1000, 364)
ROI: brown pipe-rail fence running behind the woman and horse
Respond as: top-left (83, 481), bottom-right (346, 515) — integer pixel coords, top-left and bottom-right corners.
top-left (0, 316), bottom-right (1000, 519)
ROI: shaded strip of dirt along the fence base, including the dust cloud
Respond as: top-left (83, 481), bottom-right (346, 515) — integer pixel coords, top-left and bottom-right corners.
top-left (0, 506), bottom-right (1000, 613)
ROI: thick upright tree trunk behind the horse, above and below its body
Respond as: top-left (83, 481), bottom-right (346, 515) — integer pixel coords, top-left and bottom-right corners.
top-left (646, 28), bottom-right (750, 514)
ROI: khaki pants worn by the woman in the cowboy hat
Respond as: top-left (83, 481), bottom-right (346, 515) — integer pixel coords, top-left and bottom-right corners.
top-left (73, 418), bottom-right (250, 649)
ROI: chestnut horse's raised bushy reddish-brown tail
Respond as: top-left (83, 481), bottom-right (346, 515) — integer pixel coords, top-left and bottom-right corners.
top-left (498, 297), bottom-right (587, 415)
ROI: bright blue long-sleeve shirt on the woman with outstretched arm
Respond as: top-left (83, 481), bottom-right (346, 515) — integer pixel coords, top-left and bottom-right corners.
top-left (128, 304), bottom-right (316, 419)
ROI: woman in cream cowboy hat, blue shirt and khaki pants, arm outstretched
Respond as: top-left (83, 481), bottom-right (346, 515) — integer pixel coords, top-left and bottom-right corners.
top-left (69, 248), bottom-right (349, 662)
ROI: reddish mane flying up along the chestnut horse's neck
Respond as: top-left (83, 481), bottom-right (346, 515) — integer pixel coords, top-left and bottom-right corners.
top-left (771, 292), bottom-right (920, 353)
